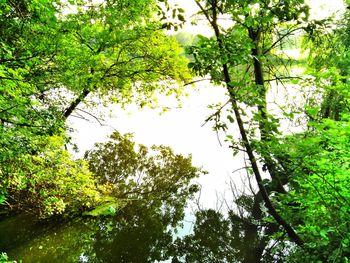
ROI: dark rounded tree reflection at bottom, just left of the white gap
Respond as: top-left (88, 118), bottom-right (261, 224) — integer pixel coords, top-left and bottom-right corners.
top-left (94, 207), bottom-right (172, 263)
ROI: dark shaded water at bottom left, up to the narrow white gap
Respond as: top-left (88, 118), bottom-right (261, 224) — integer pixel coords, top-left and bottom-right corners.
top-left (0, 207), bottom-right (172, 263)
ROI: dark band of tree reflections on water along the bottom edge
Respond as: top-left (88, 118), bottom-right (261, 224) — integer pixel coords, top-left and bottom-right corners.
top-left (0, 205), bottom-right (276, 263)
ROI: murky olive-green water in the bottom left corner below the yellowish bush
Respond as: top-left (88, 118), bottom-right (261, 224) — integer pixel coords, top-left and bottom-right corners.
top-left (0, 215), bottom-right (93, 263)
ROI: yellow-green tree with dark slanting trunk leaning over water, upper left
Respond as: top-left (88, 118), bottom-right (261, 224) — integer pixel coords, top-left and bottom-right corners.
top-left (57, 1), bottom-right (189, 118)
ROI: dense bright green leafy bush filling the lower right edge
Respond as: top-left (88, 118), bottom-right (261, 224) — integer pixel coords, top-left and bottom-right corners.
top-left (275, 119), bottom-right (350, 262)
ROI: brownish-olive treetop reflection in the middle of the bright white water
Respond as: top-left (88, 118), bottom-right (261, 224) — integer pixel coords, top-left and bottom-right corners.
top-left (86, 132), bottom-right (204, 226)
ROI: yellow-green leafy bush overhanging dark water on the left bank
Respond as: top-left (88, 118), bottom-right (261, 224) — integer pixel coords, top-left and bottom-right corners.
top-left (1, 136), bottom-right (100, 217)
